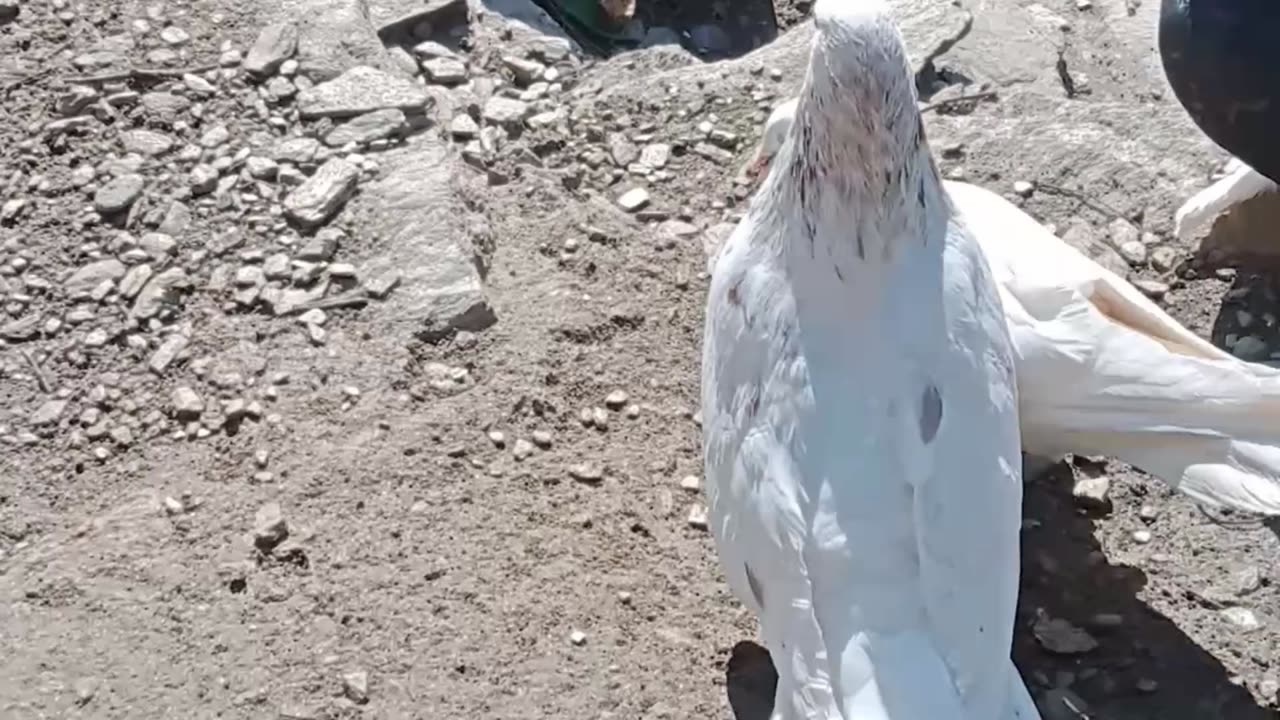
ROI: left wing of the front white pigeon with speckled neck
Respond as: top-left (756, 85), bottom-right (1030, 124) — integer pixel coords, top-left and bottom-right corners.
top-left (701, 215), bottom-right (838, 717)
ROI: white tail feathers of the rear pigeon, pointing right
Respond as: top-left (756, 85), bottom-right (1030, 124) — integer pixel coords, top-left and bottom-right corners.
top-left (1021, 329), bottom-right (1280, 515)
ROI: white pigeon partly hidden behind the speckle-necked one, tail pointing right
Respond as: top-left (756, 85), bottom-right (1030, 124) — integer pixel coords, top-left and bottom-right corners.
top-left (742, 100), bottom-right (1280, 515)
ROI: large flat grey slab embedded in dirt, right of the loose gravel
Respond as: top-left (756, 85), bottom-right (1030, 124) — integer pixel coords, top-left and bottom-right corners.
top-left (358, 136), bottom-right (497, 341)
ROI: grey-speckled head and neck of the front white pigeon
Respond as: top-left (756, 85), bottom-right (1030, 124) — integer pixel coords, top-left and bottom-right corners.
top-left (760, 0), bottom-right (948, 261)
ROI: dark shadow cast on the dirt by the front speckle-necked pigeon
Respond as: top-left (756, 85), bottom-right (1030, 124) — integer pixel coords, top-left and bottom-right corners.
top-left (726, 464), bottom-right (1276, 720)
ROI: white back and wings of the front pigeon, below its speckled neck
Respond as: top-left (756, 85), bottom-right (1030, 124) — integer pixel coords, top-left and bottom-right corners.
top-left (703, 204), bottom-right (1038, 720)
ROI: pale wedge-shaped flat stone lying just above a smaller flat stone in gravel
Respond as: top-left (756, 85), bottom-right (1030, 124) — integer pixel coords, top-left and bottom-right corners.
top-left (298, 65), bottom-right (430, 119)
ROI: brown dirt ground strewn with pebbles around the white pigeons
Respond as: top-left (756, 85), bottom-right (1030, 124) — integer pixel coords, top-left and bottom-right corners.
top-left (0, 0), bottom-right (1280, 720)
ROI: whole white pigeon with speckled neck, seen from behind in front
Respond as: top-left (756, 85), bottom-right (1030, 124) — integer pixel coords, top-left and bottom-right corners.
top-left (703, 0), bottom-right (1039, 720)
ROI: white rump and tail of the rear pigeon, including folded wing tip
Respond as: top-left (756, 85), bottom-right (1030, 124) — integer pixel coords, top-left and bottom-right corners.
top-left (1006, 271), bottom-right (1280, 515)
